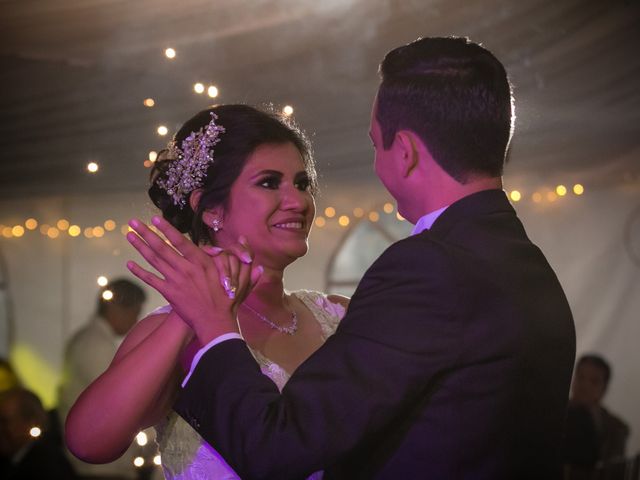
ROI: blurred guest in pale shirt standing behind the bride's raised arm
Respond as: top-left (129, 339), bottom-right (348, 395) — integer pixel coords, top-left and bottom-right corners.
top-left (58, 279), bottom-right (146, 480)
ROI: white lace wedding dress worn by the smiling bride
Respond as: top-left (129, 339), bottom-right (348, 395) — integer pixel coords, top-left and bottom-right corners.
top-left (156, 290), bottom-right (344, 480)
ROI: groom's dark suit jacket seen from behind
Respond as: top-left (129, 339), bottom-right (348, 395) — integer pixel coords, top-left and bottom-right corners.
top-left (175, 190), bottom-right (575, 480)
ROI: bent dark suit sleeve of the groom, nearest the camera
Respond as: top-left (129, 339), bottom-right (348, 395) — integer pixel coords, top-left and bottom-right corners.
top-left (174, 238), bottom-right (462, 479)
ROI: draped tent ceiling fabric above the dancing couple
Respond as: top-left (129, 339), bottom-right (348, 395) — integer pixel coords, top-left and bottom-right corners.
top-left (0, 0), bottom-right (640, 198)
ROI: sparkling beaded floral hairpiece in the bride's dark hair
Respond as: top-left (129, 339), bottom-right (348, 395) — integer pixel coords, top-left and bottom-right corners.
top-left (157, 112), bottom-right (225, 208)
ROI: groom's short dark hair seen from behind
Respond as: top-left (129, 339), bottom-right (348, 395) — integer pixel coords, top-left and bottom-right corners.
top-left (376, 37), bottom-right (514, 183)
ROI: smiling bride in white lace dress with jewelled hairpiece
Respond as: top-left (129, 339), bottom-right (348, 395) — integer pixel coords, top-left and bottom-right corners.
top-left (66, 105), bottom-right (348, 480)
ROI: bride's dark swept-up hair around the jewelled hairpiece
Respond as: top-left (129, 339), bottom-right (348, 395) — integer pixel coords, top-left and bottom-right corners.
top-left (149, 105), bottom-right (317, 245)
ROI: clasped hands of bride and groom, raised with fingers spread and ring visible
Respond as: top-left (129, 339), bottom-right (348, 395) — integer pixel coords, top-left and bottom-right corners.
top-left (127, 216), bottom-right (263, 344)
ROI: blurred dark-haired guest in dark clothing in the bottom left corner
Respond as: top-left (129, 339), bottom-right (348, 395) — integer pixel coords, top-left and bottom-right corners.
top-left (0, 387), bottom-right (76, 480)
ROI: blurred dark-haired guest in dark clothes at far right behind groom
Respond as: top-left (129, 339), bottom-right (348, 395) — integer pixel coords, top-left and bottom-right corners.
top-left (565, 354), bottom-right (629, 478)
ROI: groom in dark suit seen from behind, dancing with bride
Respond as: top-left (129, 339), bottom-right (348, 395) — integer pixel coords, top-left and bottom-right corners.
top-left (175, 38), bottom-right (575, 480)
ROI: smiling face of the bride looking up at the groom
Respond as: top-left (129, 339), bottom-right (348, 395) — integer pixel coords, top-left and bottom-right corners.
top-left (215, 143), bottom-right (315, 269)
